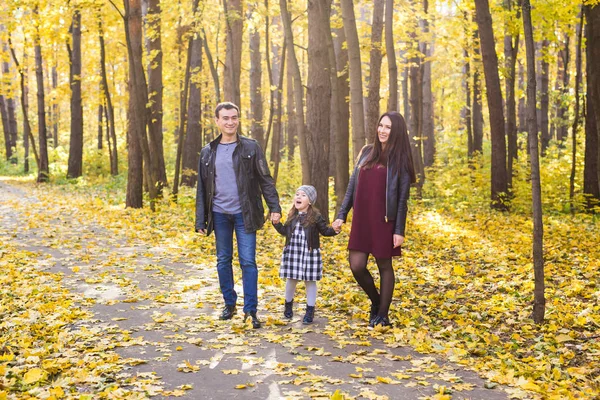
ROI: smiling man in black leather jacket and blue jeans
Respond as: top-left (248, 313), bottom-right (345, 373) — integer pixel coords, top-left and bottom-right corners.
top-left (196, 102), bottom-right (281, 329)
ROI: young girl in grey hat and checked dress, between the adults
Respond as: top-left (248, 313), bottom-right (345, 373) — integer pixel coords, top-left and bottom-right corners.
top-left (273, 185), bottom-right (340, 324)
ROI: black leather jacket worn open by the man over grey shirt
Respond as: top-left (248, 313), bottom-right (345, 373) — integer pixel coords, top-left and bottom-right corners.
top-left (196, 135), bottom-right (281, 235)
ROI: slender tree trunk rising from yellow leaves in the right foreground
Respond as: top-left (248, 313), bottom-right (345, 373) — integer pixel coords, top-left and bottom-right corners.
top-left (523, 0), bottom-right (546, 324)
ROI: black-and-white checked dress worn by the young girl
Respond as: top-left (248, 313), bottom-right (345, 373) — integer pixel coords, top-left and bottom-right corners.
top-left (279, 222), bottom-right (323, 281)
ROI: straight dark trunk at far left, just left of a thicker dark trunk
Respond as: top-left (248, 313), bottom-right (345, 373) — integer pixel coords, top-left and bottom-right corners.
top-left (34, 7), bottom-right (50, 182)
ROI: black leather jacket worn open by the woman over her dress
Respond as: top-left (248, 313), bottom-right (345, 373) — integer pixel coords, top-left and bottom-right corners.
top-left (337, 145), bottom-right (410, 236)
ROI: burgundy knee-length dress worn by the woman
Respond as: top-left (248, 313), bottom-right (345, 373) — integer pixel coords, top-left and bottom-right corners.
top-left (348, 165), bottom-right (401, 258)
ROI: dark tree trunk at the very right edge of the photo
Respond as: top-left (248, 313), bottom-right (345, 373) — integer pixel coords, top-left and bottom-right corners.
top-left (583, 5), bottom-right (600, 210)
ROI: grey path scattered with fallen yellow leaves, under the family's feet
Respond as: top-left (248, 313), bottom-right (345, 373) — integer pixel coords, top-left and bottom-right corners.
top-left (0, 181), bottom-right (508, 400)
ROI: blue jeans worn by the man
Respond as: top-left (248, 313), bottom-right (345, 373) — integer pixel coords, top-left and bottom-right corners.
top-left (213, 212), bottom-right (258, 313)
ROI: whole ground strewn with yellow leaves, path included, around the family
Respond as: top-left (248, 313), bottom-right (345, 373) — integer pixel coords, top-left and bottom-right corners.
top-left (0, 173), bottom-right (600, 399)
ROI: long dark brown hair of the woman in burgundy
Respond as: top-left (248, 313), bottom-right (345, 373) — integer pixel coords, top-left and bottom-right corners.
top-left (363, 111), bottom-right (417, 183)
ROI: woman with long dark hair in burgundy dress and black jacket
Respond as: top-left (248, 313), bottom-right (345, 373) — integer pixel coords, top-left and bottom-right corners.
top-left (332, 111), bottom-right (416, 327)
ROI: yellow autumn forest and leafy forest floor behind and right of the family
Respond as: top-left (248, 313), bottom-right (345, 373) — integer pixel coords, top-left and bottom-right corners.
top-left (0, 0), bottom-right (600, 398)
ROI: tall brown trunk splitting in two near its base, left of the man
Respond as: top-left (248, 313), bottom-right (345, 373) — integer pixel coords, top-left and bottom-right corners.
top-left (123, 0), bottom-right (158, 211)
